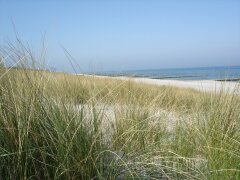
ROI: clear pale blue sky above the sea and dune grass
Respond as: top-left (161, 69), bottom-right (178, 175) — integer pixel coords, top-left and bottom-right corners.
top-left (0, 0), bottom-right (240, 71)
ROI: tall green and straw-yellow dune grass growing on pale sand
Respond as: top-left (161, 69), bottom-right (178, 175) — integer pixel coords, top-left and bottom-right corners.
top-left (0, 41), bottom-right (240, 179)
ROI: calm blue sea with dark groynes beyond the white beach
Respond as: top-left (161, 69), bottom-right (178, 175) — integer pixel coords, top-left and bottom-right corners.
top-left (98, 66), bottom-right (240, 81)
